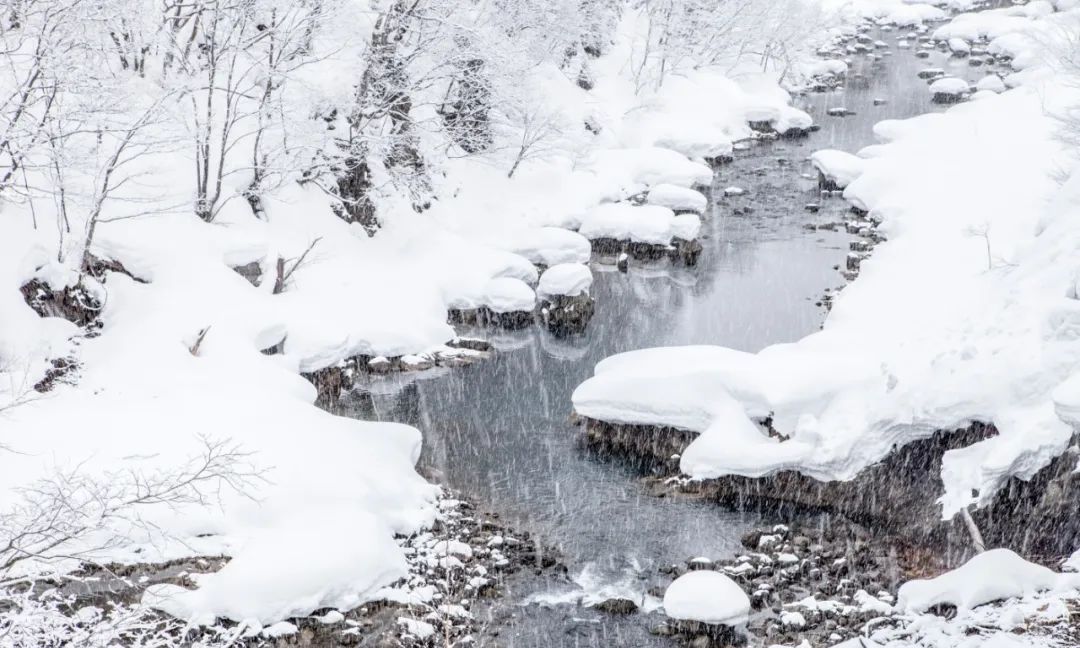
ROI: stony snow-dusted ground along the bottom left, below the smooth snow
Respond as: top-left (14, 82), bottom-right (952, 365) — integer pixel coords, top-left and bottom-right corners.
top-left (0, 491), bottom-right (565, 648)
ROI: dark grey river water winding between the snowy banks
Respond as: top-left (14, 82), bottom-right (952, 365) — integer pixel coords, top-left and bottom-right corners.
top-left (341, 31), bottom-right (985, 648)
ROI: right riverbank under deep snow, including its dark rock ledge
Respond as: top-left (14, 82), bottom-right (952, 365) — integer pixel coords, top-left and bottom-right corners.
top-left (573, 3), bottom-right (1080, 646)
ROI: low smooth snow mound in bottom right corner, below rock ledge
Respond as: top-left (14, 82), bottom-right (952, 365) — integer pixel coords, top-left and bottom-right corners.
top-left (896, 549), bottom-right (1080, 612)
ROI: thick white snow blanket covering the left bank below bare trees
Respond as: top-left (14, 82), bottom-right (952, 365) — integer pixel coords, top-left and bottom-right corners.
top-left (0, 3), bottom-right (937, 624)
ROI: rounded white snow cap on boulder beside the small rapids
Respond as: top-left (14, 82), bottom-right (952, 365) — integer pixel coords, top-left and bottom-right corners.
top-left (663, 569), bottom-right (750, 625)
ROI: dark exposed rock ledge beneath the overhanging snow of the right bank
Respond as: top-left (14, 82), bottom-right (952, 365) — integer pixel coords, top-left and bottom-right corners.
top-left (582, 419), bottom-right (1080, 557)
